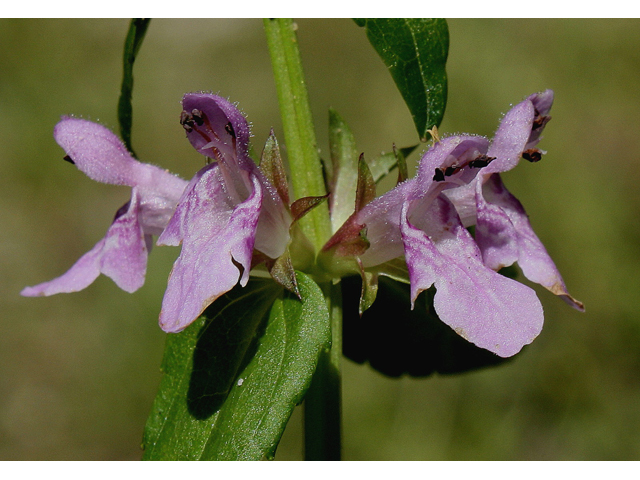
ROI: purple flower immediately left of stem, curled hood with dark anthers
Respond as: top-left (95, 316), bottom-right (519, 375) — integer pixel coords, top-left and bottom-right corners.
top-left (158, 93), bottom-right (291, 332)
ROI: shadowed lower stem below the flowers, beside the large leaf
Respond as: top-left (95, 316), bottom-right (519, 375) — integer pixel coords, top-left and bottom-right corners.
top-left (304, 283), bottom-right (342, 460)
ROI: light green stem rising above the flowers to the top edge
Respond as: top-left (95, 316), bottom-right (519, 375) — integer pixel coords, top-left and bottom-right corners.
top-left (264, 18), bottom-right (331, 252)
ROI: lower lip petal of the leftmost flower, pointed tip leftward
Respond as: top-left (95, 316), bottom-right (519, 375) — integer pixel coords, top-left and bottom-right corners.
top-left (21, 188), bottom-right (147, 297)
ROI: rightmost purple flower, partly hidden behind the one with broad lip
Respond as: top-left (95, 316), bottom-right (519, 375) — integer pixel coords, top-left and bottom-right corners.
top-left (447, 90), bottom-right (584, 311)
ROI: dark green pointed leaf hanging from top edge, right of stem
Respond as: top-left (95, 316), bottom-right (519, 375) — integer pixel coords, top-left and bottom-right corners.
top-left (355, 18), bottom-right (449, 142)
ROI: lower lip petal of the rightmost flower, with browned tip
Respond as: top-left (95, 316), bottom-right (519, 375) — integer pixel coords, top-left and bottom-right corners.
top-left (476, 174), bottom-right (584, 311)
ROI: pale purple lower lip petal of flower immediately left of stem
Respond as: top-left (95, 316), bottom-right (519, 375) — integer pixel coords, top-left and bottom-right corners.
top-left (159, 163), bottom-right (262, 332)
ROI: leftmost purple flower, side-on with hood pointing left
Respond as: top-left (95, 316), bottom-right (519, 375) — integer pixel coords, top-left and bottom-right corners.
top-left (21, 117), bottom-right (187, 297)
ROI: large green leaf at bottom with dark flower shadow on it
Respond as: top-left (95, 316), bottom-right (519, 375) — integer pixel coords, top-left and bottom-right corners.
top-left (143, 273), bottom-right (330, 460)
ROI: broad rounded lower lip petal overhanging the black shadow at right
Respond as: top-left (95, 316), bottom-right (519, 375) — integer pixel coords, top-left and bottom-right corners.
top-left (401, 196), bottom-right (543, 357)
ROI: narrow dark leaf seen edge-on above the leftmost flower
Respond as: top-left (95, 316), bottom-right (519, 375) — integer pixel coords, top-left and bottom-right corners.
top-left (118, 18), bottom-right (151, 156)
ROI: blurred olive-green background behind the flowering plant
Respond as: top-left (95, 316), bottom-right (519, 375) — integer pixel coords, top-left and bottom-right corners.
top-left (0, 19), bottom-right (640, 460)
